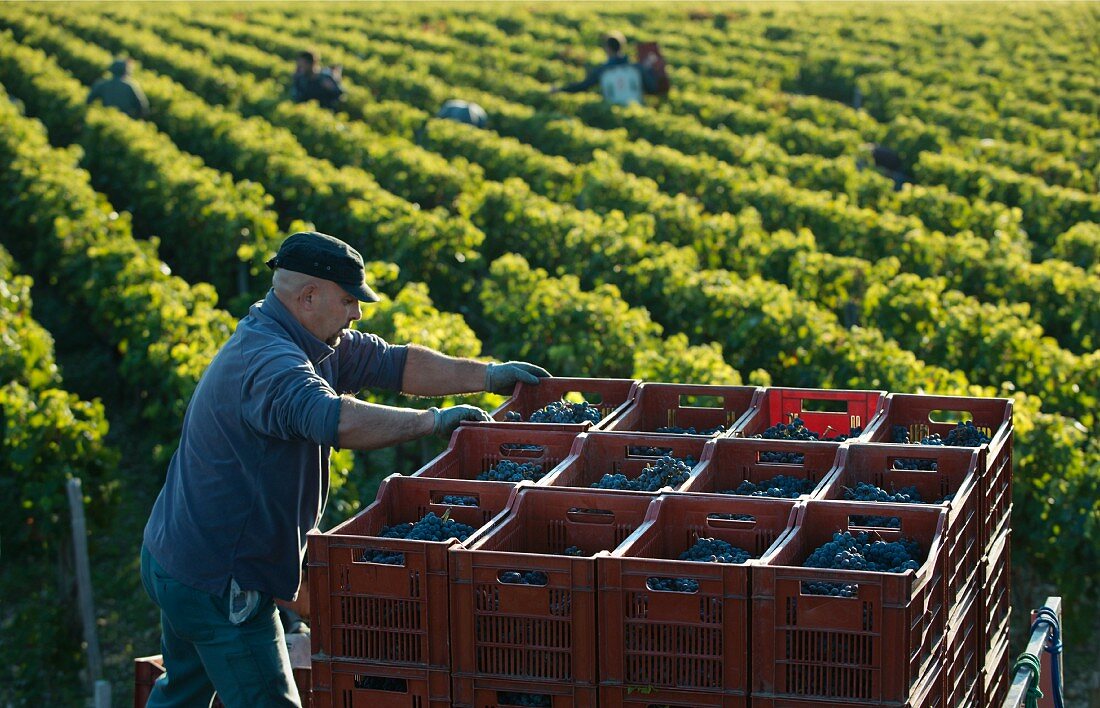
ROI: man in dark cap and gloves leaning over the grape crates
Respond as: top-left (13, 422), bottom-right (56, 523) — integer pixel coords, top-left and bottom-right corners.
top-left (141, 232), bottom-right (549, 708)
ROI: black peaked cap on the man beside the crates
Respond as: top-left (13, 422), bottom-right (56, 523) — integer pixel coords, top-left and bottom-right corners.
top-left (267, 231), bottom-right (378, 302)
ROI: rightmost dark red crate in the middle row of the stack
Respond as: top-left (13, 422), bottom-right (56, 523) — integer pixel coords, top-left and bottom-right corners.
top-left (821, 443), bottom-right (982, 609)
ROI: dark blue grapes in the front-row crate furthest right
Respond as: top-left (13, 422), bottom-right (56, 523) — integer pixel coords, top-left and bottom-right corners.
top-left (802, 531), bottom-right (921, 597)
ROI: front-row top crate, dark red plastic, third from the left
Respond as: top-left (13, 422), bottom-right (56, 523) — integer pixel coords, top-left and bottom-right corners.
top-left (597, 494), bottom-right (796, 705)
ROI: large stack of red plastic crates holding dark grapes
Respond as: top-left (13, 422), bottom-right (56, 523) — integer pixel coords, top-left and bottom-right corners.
top-left (308, 378), bottom-right (1012, 708)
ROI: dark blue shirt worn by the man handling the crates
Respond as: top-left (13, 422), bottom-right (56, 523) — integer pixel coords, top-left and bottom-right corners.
top-left (144, 291), bottom-right (408, 599)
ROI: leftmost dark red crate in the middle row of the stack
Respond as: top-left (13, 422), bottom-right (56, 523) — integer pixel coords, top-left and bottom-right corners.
top-left (411, 423), bottom-right (578, 485)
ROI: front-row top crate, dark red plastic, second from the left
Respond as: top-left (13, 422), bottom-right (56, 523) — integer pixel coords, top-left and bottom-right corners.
top-left (451, 486), bottom-right (653, 685)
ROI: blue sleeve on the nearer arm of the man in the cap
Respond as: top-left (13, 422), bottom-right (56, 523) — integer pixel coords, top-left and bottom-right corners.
top-left (241, 356), bottom-right (340, 447)
